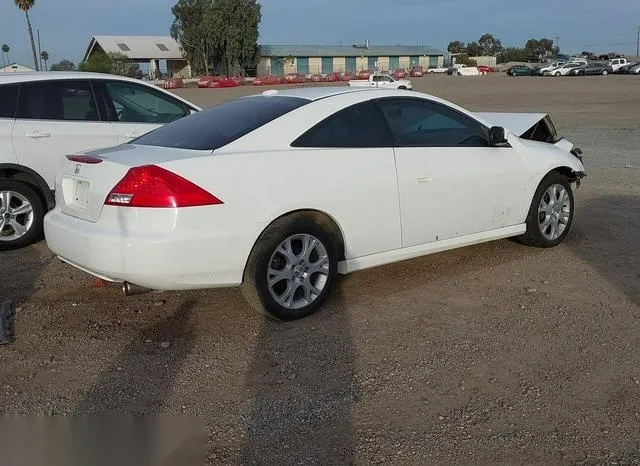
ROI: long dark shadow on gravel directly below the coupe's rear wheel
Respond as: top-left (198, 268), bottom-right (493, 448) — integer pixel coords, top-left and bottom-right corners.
top-left (241, 279), bottom-right (359, 464)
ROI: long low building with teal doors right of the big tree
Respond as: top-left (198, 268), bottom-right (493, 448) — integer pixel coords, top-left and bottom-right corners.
top-left (257, 42), bottom-right (444, 75)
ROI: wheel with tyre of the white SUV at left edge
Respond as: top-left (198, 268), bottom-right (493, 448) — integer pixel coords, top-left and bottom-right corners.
top-left (0, 180), bottom-right (44, 251)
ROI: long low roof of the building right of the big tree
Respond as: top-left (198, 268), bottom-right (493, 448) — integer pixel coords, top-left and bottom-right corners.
top-left (260, 45), bottom-right (444, 57)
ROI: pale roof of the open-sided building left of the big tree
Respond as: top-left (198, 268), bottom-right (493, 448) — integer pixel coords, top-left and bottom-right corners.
top-left (83, 36), bottom-right (184, 60)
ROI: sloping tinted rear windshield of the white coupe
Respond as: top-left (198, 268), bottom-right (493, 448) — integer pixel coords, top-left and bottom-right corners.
top-left (131, 96), bottom-right (310, 150)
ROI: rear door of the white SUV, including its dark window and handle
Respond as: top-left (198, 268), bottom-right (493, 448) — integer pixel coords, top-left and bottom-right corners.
top-left (12, 79), bottom-right (118, 189)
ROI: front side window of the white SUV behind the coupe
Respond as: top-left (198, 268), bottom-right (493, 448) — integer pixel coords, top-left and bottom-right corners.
top-left (104, 81), bottom-right (188, 124)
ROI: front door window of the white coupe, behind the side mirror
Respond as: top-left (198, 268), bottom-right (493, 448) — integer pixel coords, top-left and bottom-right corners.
top-left (378, 99), bottom-right (489, 147)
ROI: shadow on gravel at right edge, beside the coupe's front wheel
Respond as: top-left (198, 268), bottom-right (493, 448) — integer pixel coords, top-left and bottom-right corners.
top-left (567, 196), bottom-right (640, 305)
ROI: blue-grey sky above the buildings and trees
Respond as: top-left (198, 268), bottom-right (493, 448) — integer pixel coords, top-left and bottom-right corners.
top-left (0, 0), bottom-right (640, 67)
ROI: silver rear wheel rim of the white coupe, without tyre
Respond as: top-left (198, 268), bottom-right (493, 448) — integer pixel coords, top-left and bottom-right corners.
top-left (267, 234), bottom-right (329, 309)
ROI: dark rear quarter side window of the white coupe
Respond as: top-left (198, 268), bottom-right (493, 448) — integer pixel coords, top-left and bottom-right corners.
top-left (291, 102), bottom-right (391, 147)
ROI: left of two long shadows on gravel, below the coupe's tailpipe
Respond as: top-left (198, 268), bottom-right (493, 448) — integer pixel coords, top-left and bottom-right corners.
top-left (61, 300), bottom-right (200, 466)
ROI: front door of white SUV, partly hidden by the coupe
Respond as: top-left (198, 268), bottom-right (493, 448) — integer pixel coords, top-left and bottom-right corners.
top-left (95, 80), bottom-right (192, 143)
